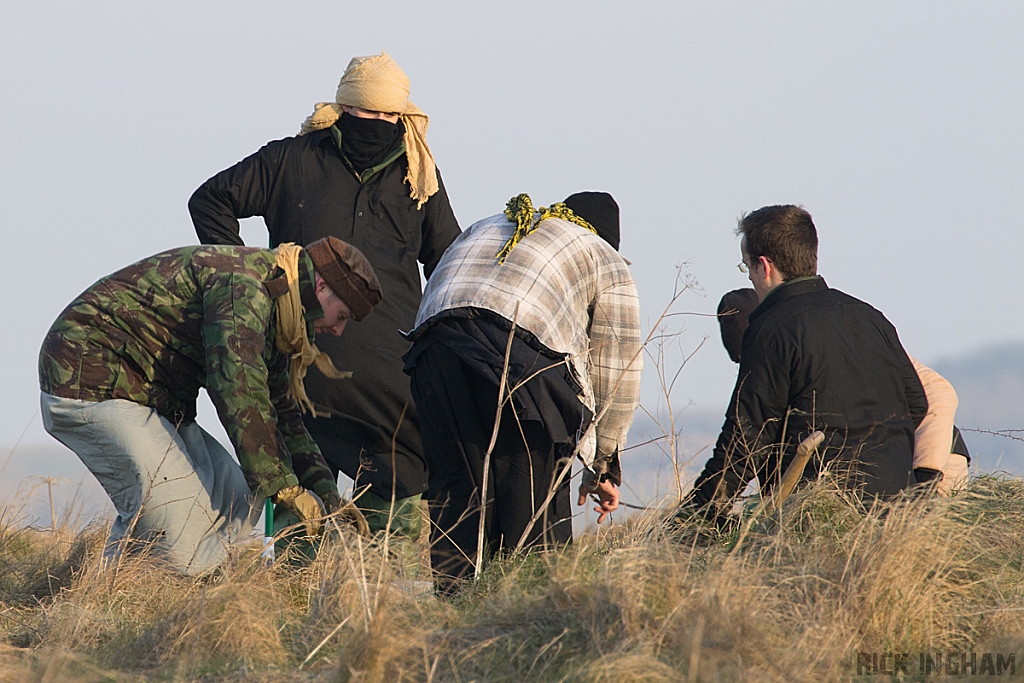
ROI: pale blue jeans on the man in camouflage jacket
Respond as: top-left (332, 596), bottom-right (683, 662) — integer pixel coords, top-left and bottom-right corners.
top-left (40, 393), bottom-right (262, 574)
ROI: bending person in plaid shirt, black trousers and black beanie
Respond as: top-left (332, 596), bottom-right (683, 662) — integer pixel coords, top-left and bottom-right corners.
top-left (406, 193), bottom-right (642, 593)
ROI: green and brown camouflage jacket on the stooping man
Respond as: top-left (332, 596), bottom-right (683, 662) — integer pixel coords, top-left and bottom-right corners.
top-left (39, 247), bottom-right (337, 498)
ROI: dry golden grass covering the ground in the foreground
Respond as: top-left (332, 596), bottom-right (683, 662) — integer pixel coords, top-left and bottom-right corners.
top-left (0, 478), bottom-right (1024, 683)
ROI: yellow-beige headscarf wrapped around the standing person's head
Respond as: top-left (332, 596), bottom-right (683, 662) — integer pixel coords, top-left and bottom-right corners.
top-left (299, 52), bottom-right (437, 208)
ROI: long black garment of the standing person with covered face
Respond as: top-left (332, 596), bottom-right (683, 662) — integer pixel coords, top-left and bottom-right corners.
top-left (188, 129), bottom-right (460, 497)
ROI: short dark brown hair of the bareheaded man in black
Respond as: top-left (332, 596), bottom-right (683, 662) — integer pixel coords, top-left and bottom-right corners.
top-left (736, 204), bottom-right (818, 280)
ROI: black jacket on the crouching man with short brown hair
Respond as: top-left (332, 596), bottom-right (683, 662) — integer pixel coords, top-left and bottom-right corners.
top-left (693, 276), bottom-right (928, 505)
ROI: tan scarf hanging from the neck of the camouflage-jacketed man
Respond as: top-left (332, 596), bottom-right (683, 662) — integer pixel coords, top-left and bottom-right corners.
top-left (273, 242), bottom-right (352, 418)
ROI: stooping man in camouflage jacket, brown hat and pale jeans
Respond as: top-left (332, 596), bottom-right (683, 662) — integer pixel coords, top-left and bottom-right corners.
top-left (39, 238), bottom-right (381, 573)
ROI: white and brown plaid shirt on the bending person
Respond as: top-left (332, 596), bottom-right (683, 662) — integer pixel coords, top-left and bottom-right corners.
top-left (414, 214), bottom-right (643, 472)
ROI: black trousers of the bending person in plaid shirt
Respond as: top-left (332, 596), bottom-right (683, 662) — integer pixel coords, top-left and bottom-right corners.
top-left (411, 343), bottom-right (572, 592)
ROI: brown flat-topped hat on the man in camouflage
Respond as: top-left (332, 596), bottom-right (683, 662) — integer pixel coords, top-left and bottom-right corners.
top-left (305, 237), bottom-right (383, 321)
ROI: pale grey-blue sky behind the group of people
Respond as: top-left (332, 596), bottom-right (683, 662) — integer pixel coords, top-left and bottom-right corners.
top-left (0, 1), bottom-right (1024, 462)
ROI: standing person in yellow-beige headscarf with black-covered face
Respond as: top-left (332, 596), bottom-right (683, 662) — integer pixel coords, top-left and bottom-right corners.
top-left (188, 53), bottom-right (460, 572)
